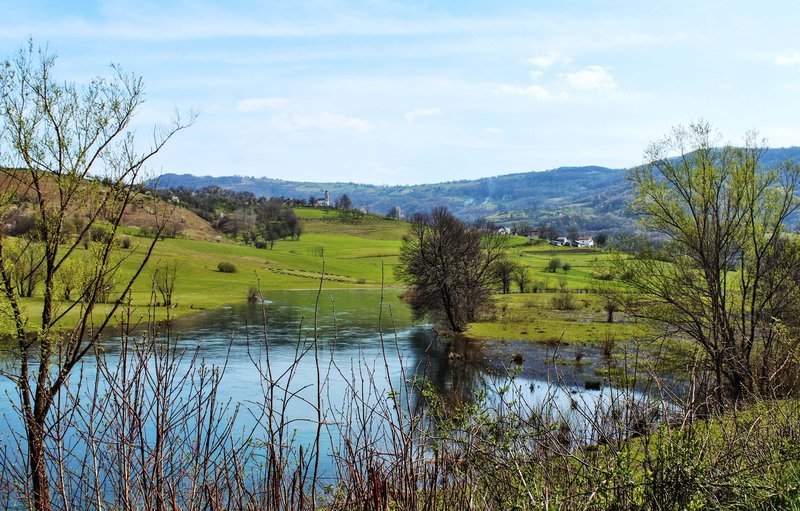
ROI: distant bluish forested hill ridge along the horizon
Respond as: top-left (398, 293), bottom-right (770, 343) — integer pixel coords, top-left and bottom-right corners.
top-left (158, 147), bottom-right (800, 230)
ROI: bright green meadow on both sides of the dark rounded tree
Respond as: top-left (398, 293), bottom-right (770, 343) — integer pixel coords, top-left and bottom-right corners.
top-left (4, 208), bottom-right (645, 343)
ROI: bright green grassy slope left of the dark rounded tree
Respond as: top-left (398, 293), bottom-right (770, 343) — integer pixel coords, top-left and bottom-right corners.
top-left (4, 209), bottom-right (406, 329)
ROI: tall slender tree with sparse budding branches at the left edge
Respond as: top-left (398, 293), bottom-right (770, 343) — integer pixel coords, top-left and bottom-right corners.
top-left (0, 42), bottom-right (188, 511)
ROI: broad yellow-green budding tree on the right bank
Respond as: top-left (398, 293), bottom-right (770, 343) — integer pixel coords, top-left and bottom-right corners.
top-left (624, 123), bottom-right (800, 405)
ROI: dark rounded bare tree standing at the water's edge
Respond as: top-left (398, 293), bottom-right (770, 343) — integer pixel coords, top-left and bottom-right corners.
top-left (395, 208), bottom-right (510, 332)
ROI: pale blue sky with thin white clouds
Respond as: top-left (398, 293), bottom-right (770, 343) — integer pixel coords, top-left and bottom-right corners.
top-left (0, 0), bottom-right (800, 185)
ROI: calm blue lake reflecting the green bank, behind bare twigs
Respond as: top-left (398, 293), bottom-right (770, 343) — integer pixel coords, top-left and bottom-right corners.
top-left (0, 290), bottom-right (648, 488)
